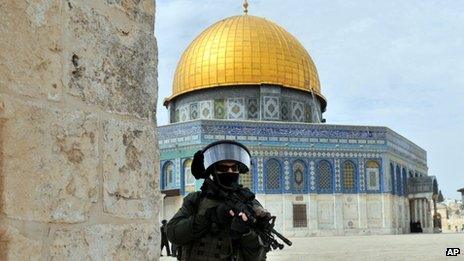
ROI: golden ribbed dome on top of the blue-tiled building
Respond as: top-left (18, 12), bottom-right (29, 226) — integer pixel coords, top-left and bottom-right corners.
top-left (169, 15), bottom-right (322, 99)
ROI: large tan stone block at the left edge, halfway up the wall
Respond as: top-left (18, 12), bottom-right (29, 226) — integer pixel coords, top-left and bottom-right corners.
top-left (0, 95), bottom-right (98, 223)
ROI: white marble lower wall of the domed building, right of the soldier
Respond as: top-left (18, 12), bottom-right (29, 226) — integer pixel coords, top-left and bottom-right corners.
top-left (257, 194), bottom-right (409, 237)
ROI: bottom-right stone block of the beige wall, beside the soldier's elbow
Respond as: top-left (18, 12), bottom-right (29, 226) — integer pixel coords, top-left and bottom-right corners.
top-left (50, 224), bottom-right (160, 260)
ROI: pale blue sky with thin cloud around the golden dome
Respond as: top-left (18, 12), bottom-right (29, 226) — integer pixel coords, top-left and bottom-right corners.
top-left (155, 0), bottom-right (464, 198)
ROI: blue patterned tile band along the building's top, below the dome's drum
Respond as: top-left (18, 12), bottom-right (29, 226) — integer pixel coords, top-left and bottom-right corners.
top-left (159, 120), bottom-right (426, 174)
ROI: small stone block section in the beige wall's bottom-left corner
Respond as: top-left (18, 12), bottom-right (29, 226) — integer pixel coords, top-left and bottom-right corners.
top-left (0, 225), bottom-right (42, 260)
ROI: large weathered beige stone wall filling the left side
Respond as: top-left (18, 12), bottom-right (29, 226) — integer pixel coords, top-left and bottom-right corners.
top-left (0, 0), bottom-right (160, 260)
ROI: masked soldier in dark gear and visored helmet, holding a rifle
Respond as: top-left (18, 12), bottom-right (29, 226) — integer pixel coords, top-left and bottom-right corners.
top-left (167, 141), bottom-right (269, 261)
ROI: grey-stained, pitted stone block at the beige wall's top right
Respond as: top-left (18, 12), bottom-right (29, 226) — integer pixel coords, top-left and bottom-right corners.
top-left (64, 0), bottom-right (157, 119)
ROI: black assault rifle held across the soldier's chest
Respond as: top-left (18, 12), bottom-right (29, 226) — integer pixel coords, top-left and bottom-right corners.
top-left (202, 178), bottom-right (292, 251)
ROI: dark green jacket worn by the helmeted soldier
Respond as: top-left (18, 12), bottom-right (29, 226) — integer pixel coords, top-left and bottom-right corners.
top-left (167, 191), bottom-right (266, 261)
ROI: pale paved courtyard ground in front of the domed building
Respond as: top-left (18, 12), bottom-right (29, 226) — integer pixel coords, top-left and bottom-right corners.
top-left (160, 234), bottom-right (464, 261)
